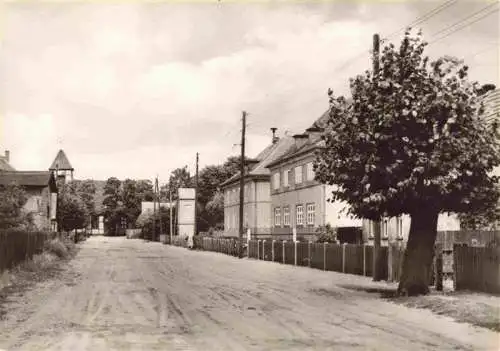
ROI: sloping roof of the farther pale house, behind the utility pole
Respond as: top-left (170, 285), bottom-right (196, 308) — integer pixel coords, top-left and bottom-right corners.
top-left (221, 136), bottom-right (295, 187)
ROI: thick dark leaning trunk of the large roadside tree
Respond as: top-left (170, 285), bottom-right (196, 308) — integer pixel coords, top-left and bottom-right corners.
top-left (398, 209), bottom-right (439, 296)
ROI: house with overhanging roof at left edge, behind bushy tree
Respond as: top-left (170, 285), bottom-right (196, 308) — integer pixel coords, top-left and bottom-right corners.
top-left (0, 151), bottom-right (57, 230)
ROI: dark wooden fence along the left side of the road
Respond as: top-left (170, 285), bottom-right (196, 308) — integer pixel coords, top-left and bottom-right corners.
top-left (0, 230), bottom-right (54, 273)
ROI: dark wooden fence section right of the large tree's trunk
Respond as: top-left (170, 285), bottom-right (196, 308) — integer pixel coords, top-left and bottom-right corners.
top-left (453, 245), bottom-right (500, 294)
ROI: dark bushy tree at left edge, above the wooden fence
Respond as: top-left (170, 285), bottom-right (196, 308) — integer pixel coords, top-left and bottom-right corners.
top-left (0, 184), bottom-right (32, 229)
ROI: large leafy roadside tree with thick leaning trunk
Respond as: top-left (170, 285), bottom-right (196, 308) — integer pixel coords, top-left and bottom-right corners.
top-left (315, 31), bottom-right (500, 295)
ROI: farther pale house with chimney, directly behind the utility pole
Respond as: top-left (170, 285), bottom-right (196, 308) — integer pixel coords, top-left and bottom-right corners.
top-left (221, 128), bottom-right (294, 237)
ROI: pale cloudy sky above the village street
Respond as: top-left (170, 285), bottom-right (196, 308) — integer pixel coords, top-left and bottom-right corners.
top-left (0, 0), bottom-right (500, 182)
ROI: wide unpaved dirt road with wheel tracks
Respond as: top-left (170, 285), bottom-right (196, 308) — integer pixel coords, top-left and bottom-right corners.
top-left (0, 237), bottom-right (499, 351)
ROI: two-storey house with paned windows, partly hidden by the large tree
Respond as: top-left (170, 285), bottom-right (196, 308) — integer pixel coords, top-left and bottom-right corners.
top-left (266, 112), bottom-right (362, 242)
